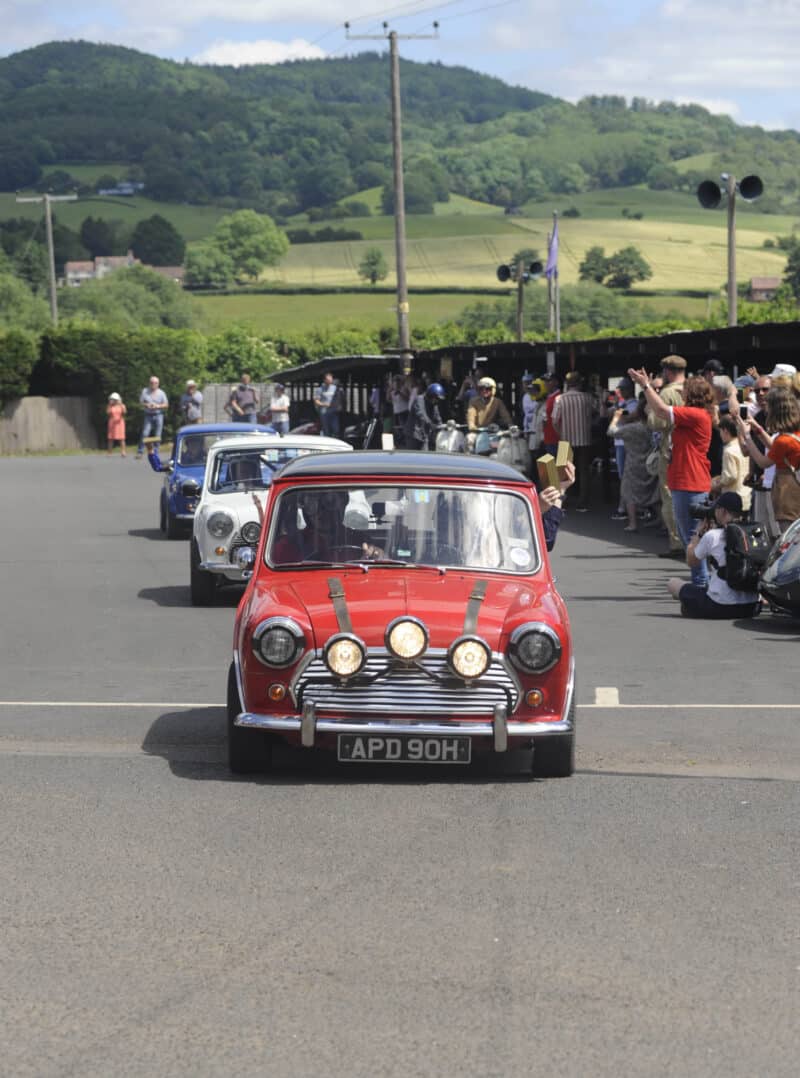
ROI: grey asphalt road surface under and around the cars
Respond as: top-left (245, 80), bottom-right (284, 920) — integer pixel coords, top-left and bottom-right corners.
top-left (0, 456), bottom-right (800, 1078)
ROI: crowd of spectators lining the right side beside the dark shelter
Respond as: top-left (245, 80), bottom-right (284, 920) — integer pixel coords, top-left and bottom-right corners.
top-left (370, 355), bottom-right (800, 618)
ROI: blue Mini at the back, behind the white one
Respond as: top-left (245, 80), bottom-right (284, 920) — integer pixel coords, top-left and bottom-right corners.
top-left (153, 423), bottom-right (275, 539)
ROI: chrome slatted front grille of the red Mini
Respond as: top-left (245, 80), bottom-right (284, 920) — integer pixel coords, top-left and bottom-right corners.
top-left (292, 651), bottom-right (520, 717)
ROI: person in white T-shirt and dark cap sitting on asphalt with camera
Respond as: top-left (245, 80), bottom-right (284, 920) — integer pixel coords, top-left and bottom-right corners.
top-left (666, 490), bottom-right (759, 619)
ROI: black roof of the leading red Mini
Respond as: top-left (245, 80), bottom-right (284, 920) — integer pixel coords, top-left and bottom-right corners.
top-left (273, 450), bottom-right (530, 483)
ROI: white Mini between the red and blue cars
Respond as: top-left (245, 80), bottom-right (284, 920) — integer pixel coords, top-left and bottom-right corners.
top-left (190, 433), bottom-right (353, 606)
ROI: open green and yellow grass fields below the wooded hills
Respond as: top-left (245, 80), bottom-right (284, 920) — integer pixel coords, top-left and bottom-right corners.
top-left (6, 168), bottom-right (800, 330)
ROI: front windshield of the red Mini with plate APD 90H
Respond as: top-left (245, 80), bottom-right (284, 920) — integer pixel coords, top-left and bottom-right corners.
top-left (264, 485), bottom-right (540, 573)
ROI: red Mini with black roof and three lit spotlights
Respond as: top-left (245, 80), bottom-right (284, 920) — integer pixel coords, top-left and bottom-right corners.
top-left (227, 452), bottom-right (575, 777)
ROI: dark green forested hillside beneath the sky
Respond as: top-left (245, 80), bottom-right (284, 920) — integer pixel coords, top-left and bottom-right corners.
top-left (0, 42), bottom-right (800, 217)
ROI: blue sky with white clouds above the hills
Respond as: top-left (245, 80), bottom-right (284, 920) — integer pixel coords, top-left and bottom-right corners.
top-left (6, 0), bottom-right (800, 129)
